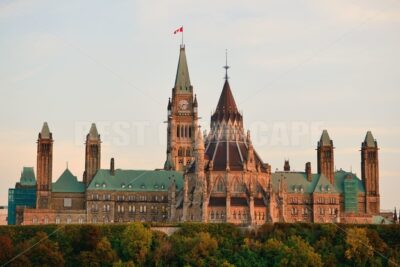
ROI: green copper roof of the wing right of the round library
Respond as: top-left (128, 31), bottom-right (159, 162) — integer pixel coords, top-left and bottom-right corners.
top-left (271, 170), bottom-right (365, 194)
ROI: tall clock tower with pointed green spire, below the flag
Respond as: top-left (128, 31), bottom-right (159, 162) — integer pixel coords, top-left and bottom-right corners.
top-left (164, 45), bottom-right (198, 172)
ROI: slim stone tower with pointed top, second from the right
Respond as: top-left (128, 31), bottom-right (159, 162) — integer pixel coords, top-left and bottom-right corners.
top-left (317, 130), bottom-right (335, 185)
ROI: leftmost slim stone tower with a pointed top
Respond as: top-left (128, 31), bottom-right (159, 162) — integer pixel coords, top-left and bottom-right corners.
top-left (36, 122), bottom-right (53, 209)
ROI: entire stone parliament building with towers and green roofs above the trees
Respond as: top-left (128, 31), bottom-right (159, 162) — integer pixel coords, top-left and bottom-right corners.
top-left (8, 45), bottom-right (383, 226)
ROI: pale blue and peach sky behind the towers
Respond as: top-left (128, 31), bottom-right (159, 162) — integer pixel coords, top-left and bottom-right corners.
top-left (0, 0), bottom-right (400, 210)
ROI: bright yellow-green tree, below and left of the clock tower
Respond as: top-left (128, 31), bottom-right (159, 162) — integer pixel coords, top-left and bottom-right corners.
top-left (121, 223), bottom-right (152, 265)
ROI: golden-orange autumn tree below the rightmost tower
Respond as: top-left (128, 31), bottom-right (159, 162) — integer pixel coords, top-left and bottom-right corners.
top-left (345, 227), bottom-right (374, 266)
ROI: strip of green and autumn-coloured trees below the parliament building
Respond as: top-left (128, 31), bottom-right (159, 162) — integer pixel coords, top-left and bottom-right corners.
top-left (0, 223), bottom-right (400, 267)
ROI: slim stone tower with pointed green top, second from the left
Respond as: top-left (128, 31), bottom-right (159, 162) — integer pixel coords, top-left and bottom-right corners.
top-left (83, 123), bottom-right (101, 186)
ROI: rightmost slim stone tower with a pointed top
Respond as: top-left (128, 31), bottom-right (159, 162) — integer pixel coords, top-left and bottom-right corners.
top-left (361, 131), bottom-right (380, 214)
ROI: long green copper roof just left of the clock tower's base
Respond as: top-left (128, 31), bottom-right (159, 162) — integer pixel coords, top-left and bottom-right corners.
top-left (88, 169), bottom-right (183, 192)
